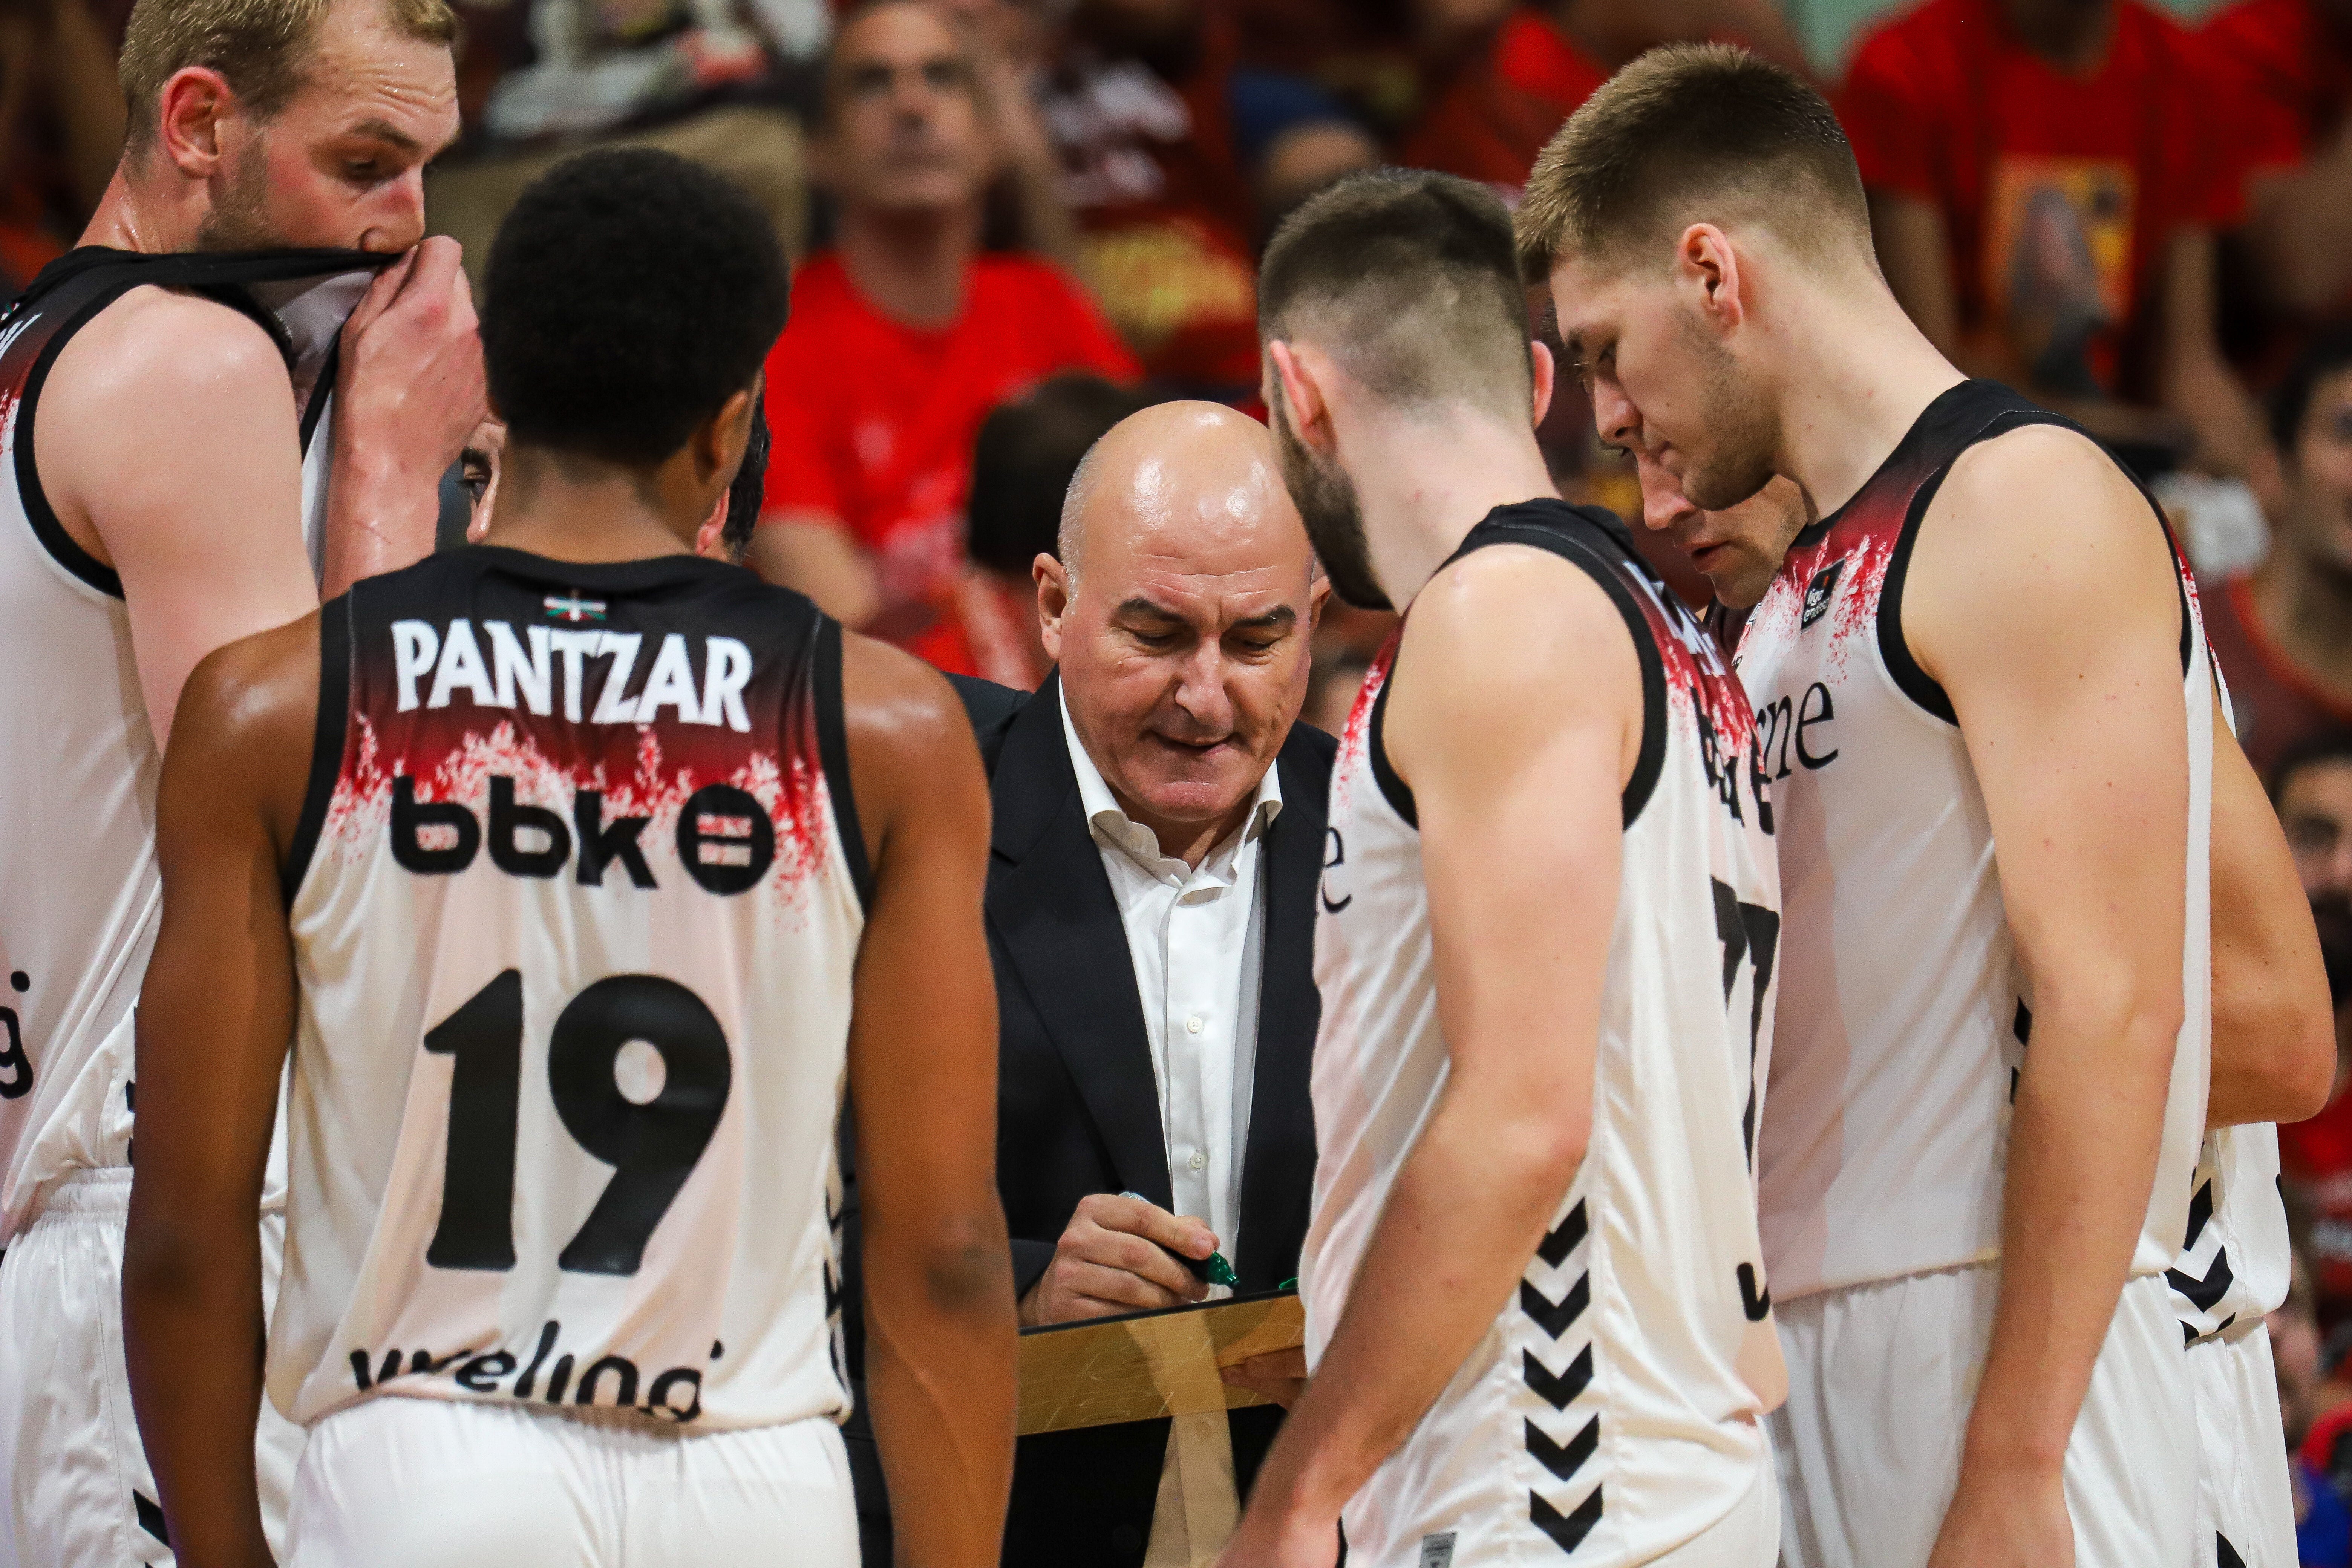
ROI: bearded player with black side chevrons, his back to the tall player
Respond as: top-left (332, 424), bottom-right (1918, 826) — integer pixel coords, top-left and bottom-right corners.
top-left (1228, 172), bottom-right (1783, 1568)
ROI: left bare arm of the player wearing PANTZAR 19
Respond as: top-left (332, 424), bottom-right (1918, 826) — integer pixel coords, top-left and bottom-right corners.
top-left (122, 616), bottom-right (317, 1568)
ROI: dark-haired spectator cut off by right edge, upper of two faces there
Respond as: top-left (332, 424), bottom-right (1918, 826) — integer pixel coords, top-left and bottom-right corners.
top-left (2204, 329), bottom-right (2352, 771)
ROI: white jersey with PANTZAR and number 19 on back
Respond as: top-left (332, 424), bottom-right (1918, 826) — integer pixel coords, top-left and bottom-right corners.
top-left (268, 545), bottom-right (865, 1427)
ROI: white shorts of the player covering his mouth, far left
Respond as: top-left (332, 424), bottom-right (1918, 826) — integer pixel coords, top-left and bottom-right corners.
top-left (0, 1168), bottom-right (301, 1568)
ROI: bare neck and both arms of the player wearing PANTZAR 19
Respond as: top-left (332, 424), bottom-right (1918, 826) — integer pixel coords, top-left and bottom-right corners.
top-left (122, 393), bottom-right (1014, 1568)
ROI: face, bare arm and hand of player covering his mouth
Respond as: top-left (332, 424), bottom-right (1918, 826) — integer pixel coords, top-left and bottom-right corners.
top-left (33, 0), bottom-right (482, 745)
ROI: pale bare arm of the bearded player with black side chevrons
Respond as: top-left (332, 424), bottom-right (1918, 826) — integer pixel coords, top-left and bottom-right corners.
top-left (1225, 545), bottom-right (1642, 1568)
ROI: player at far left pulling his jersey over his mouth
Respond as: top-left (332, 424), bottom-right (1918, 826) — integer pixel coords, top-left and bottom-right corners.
top-left (0, 0), bottom-right (480, 1568)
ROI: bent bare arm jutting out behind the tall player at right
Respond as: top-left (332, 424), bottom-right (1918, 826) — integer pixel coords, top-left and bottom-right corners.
top-left (2206, 701), bottom-right (2335, 1126)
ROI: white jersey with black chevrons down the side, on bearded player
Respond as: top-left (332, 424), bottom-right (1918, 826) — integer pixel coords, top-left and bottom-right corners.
top-left (1301, 501), bottom-right (1785, 1568)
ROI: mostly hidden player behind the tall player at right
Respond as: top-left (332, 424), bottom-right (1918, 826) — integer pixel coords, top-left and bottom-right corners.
top-left (1635, 444), bottom-right (2335, 1568)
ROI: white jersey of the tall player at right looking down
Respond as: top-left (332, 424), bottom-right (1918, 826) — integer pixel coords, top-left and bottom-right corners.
top-left (1738, 381), bottom-right (2213, 1300)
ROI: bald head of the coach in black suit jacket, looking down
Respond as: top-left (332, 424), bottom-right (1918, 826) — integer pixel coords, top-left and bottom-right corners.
top-left (1037, 402), bottom-right (1324, 865)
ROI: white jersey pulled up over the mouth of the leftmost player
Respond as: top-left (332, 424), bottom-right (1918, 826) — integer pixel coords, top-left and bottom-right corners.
top-left (0, 249), bottom-right (360, 1243)
